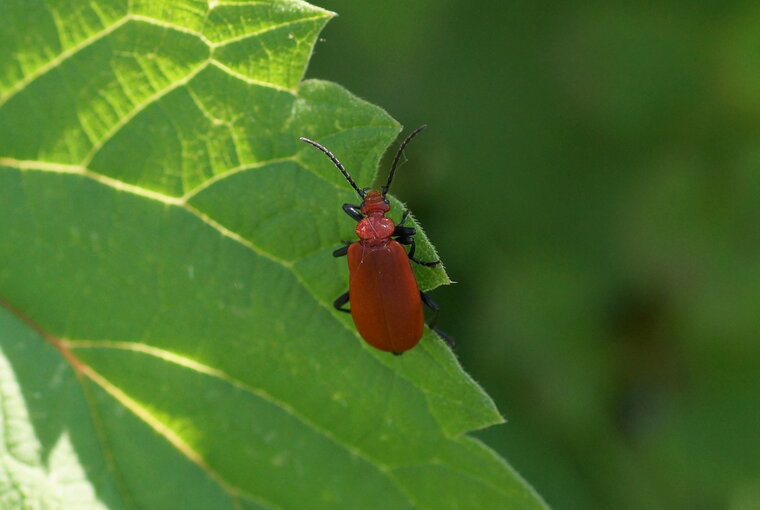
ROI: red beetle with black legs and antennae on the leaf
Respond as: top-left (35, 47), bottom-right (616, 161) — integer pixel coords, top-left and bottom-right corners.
top-left (301, 126), bottom-right (453, 354)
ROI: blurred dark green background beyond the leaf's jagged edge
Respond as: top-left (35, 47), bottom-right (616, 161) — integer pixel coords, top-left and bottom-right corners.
top-left (307, 0), bottom-right (760, 509)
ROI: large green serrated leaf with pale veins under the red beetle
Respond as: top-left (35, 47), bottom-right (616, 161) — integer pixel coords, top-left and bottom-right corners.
top-left (0, 0), bottom-right (543, 509)
